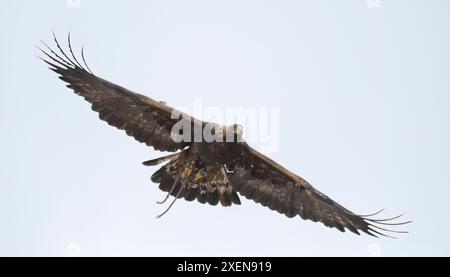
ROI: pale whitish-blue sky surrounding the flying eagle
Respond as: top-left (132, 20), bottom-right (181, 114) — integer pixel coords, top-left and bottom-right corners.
top-left (0, 0), bottom-right (450, 256)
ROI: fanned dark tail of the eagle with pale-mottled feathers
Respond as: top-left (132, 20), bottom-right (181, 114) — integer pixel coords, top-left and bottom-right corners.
top-left (144, 150), bottom-right (241, 217)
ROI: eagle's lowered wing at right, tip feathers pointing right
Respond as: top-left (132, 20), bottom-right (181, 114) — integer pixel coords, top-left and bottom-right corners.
top-left (228, 145), bottom-right (409, 236)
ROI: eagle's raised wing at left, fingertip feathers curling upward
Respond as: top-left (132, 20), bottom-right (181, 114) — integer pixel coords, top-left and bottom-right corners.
top-left (38, 35), bottom-right (202, 152)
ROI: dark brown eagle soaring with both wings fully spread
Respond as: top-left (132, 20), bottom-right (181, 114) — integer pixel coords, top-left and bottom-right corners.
top-left (38, 34), bottom-right (410, 237)
